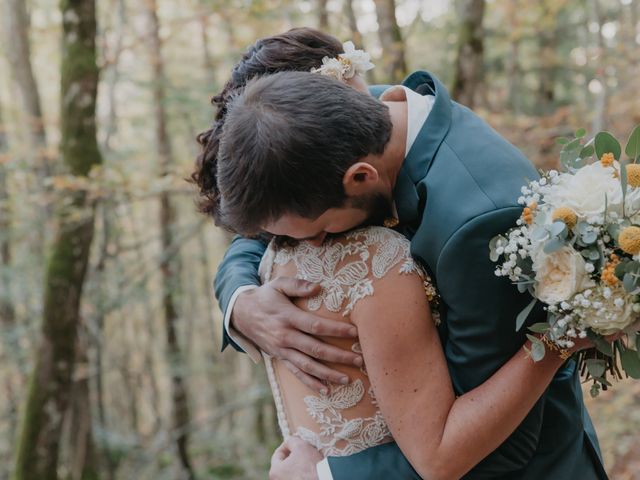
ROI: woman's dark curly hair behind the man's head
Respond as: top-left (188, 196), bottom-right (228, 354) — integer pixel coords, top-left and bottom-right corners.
top-left (191, 28), bottom-right (342, 224)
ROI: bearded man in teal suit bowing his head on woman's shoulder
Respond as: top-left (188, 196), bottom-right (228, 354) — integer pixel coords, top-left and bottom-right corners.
top-left (216, 68), bottom-right (607, 480)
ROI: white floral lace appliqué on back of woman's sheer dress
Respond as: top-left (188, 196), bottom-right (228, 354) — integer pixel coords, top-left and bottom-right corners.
top-left (260, 227), bottom-right (437, 456)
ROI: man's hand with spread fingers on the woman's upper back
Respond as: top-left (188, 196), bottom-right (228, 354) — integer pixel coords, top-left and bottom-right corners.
top-left (231, 277), bottom-right (362, 392)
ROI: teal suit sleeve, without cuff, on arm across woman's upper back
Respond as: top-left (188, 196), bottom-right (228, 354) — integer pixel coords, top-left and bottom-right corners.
top-left (214, 236), bottom-right (266, 351)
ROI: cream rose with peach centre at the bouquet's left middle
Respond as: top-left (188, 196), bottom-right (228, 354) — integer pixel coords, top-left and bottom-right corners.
top-left (533, 246), bottom-right (595, 305)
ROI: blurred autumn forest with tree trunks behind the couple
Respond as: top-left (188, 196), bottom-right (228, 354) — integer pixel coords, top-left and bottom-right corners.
top-left (0, 0), bottom-right (640, 480)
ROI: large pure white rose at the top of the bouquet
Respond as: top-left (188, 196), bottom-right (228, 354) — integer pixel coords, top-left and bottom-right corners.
top-left (544, 162), bottom-right (620, 219)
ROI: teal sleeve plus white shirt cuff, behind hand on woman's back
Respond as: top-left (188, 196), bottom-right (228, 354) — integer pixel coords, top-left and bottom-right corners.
top-left (214, 235), bottom-right (266, 354)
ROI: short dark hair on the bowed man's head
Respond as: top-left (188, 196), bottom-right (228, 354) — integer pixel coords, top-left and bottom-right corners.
top-left (217, 72), bottom-right (392, 235)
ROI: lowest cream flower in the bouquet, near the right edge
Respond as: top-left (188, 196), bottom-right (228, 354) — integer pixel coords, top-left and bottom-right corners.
top-left (579, 283), bottom-right (638, 335)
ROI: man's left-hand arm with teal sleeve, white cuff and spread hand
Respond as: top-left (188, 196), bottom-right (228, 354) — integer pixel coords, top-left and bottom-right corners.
top-left (215, 237), bottom-right (362, 392)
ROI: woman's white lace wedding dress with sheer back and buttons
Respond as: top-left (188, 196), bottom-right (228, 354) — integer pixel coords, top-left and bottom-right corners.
top-left (260, 227), bottom-right (436, 456)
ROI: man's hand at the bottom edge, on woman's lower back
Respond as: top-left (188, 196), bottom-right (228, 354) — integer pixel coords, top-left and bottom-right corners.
top-left (269, 437), bottom-right (324, 480)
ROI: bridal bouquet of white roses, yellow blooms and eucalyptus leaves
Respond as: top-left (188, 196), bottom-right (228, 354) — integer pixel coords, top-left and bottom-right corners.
top-left (489, 126), bottom-right (640, 396)
